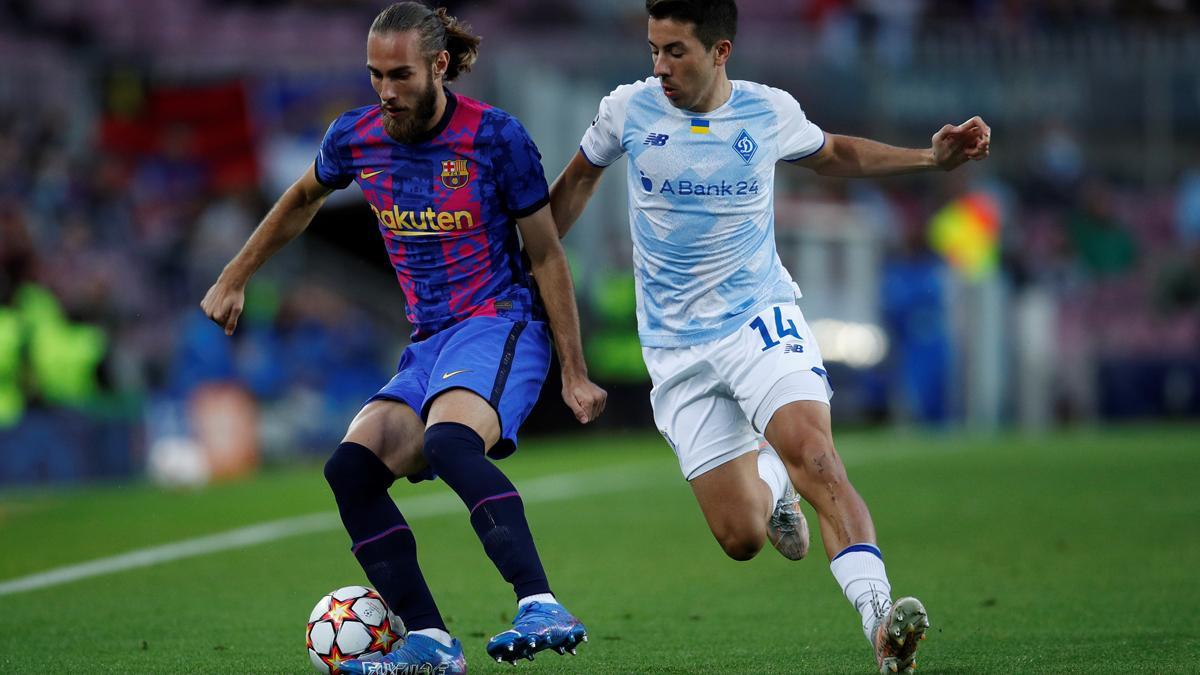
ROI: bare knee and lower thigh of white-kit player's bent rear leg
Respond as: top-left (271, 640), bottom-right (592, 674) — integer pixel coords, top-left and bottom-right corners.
top-left (689, 453), bottom-right (770, 545)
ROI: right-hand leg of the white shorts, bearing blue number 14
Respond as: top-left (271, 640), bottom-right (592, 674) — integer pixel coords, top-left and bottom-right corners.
top-left (712, 300), bottom-right (833, 429)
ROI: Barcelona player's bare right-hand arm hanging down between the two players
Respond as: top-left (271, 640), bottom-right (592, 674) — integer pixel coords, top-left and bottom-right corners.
top-left (517, 205), bottom-right (608, 424)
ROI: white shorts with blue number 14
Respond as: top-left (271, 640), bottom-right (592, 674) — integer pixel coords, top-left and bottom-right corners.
top-left (642, 305), bottom-right (833, 480)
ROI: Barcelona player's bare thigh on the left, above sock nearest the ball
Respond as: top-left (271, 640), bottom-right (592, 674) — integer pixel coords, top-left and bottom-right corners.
top-left (342, 399), bottom-right (427, 477)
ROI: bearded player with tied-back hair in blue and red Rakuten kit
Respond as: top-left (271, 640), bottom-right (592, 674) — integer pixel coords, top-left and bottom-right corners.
top-left (202, 2), bottom-right (606, 673)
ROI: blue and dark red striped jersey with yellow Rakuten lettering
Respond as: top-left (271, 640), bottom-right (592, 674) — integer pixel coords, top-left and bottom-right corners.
top-left (316, 91), bottom-right (550, 341)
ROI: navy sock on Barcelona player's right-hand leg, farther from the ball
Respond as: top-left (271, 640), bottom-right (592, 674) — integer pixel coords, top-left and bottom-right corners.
top-left (425, 422), bottom-right (550, 599)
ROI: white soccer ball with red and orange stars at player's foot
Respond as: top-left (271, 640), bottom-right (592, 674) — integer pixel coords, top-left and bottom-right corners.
top-left (305, 586), bottom-right (404, 675)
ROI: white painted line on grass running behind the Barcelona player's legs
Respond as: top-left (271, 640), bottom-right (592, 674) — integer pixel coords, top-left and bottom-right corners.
top-left (0, 462), bottom-right (662, 596)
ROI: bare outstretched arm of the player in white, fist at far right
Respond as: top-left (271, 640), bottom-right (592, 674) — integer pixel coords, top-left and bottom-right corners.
top-left (794, 117), bottom-right (991, 178)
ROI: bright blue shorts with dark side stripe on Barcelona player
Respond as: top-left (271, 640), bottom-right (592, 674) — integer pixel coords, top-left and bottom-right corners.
top-left (367, 316), bottom-right (550, 466)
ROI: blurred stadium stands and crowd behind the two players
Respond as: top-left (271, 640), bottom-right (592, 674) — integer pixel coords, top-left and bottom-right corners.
top-left (0, 0), bottom-right (1200, 484)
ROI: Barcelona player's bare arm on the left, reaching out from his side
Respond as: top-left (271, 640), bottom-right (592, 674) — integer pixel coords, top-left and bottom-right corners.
top-left (200, 167), bottom-right (332, 335)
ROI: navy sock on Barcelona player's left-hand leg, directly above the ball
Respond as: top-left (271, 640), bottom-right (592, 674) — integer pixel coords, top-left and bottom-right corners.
top-left (325, 443), bottom-right (446, 631)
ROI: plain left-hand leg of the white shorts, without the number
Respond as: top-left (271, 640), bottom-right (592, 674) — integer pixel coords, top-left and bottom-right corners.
top-left (643, 348), bottom-right (758, 480)
